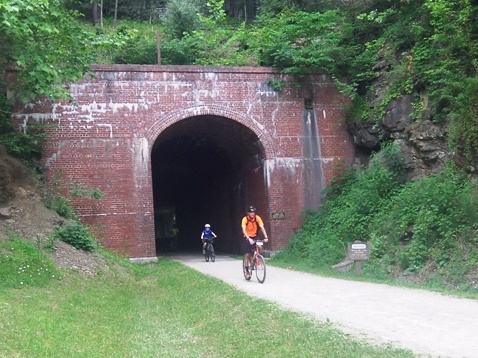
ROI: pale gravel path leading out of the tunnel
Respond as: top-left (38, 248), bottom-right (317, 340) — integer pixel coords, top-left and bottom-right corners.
top-left (173, 255), bottom-right (478, 358)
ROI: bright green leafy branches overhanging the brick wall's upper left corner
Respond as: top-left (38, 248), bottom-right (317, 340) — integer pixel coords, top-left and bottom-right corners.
top-left (0, 0), bottom-right (97, 101)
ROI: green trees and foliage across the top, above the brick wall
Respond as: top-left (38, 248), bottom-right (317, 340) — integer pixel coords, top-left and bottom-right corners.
top-left (0, 0), bottom-right (478, 160)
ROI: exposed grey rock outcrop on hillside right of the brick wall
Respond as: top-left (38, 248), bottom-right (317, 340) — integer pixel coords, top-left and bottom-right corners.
top-left (348, 96), bottom-right (452, 178)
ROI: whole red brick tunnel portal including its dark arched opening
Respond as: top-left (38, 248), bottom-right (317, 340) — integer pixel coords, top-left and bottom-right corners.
top-left (7, 65), bottom-right (354, 258)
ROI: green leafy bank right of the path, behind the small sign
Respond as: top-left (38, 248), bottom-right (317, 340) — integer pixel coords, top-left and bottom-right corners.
top-left (276, 146), bottom-right (478, 291)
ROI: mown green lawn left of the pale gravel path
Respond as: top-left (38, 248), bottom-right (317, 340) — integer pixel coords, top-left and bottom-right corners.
top-left (0, 242), bottom-right (413, 358)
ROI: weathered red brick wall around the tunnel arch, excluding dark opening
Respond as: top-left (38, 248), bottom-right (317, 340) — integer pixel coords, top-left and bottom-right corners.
top-left (10, 65), bottom-right (353, 257)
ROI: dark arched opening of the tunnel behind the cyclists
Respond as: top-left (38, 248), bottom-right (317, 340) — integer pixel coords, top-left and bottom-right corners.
top-left (151, 115), bottom-right (267, 254)
